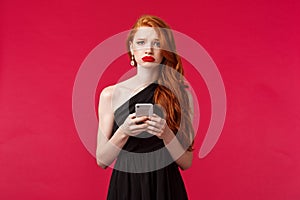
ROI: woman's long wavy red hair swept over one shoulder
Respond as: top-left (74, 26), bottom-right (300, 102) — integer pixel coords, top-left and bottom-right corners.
top-left (127, 15), bottom-right (194, 151)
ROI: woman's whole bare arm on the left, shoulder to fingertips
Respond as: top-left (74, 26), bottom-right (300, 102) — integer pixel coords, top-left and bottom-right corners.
top-left (96, 87), bottom-right (147, 169)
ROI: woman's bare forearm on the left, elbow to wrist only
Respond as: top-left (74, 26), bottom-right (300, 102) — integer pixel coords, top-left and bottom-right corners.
top-left (96, 128), bottom-right (129, 168)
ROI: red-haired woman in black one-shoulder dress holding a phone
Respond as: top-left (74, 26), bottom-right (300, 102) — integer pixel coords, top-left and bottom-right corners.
top-left (96, 15), bottom-right (194, 200)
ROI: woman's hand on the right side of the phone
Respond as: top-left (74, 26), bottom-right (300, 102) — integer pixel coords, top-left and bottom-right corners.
top-left (146, 114), bottom-right (169, 139)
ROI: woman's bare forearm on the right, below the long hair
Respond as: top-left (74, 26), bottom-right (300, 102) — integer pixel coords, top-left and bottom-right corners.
top-left (163, 128), bottom-right (193, 170)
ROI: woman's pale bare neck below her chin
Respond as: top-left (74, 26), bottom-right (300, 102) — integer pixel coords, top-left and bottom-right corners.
top-left (135, 66), bottom-right (160, 84)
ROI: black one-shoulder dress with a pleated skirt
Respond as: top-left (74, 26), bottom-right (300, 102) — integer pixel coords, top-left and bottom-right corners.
top-left (107, 83), bottom-right (188, 200)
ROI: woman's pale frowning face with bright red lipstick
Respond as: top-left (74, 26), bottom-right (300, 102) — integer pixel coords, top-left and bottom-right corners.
top-left (130, 27), bottom-right (163, 67)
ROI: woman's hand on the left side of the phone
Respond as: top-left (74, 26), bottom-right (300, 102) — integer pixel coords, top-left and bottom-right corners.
top-left (119, 113), bottom-right (148, 136)
